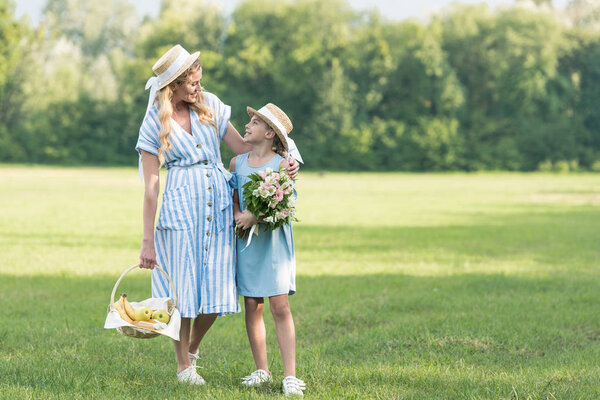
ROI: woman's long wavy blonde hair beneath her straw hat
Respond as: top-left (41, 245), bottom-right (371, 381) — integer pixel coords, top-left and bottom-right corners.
top-left (156, 60), bottom-right (217, 165)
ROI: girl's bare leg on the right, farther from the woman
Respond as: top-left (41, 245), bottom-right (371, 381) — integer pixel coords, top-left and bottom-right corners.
top-left (269, 294), bottom-right (296, 376)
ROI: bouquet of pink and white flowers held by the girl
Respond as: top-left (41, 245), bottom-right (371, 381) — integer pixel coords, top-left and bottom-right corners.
top-left (236, 168), bottom-right (298, 239)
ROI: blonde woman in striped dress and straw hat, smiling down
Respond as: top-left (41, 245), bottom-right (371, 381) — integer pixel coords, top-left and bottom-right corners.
top-left (136, 45), bottom-right (298, 385)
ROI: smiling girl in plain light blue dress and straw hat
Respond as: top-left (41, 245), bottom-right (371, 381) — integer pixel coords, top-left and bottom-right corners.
top-left (229, 103), bottom-right (305, 396)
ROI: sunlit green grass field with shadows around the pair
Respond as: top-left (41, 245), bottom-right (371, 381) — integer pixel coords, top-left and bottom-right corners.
top-left (0, 166), bottom-right (600, 399)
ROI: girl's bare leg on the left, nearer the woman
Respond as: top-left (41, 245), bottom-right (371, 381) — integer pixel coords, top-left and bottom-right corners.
top-left (244, 297), bottom-right (269, 372)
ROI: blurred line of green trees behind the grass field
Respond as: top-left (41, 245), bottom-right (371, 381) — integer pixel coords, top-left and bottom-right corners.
top-left (0, 0), bottom-right (600, 171)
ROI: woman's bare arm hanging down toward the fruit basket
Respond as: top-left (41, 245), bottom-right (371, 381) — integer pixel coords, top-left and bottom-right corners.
top-left (140, 150), bottom-right (160, 269)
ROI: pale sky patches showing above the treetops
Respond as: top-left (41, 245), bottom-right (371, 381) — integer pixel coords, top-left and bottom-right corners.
top-left (16, 0), bottom-right (568, 25)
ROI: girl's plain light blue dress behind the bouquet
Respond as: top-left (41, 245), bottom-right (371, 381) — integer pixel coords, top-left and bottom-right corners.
top-left (233, 153), bottom-right (296, 297)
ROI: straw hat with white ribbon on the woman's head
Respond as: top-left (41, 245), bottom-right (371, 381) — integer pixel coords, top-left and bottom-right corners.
top-left (146, 44), bottom-right (200, 117)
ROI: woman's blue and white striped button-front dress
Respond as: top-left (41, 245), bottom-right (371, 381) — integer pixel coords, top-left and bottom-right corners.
top-left (136, 92), bottom-right (240, 318)
